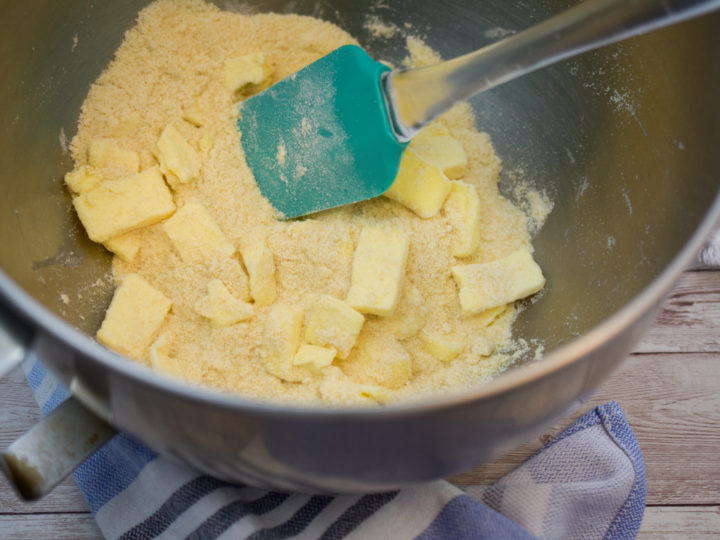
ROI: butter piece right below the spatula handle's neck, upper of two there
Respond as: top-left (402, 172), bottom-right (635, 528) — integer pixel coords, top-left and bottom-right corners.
top-left (408, 123), bottom-right (467, 178)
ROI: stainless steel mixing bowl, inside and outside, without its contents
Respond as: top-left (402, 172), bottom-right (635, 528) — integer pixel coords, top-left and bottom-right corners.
top-left (0, 0), bottom-right (720, 498)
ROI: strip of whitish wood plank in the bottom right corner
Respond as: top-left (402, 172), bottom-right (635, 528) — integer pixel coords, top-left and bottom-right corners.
top-left (637, 506), bottom-right (720, 540)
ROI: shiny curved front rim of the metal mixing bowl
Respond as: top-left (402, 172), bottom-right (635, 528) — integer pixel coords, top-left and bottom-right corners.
top-left (0, 192), bottom-right (720, 421)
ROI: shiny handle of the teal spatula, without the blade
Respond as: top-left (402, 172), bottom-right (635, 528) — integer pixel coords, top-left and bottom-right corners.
top-left (384, 0), bottom-right (720, 141)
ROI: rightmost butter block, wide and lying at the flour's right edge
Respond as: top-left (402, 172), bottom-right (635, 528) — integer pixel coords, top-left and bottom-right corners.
top-left (452, 249), bottom-right (545, 316)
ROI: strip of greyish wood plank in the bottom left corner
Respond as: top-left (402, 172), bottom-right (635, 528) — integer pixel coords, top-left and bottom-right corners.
top-left (0, 514), bottom-right (103, 540)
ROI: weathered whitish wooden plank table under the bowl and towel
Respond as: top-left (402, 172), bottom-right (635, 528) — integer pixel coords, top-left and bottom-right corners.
top-left (0, 268), bottom-right (720, 540)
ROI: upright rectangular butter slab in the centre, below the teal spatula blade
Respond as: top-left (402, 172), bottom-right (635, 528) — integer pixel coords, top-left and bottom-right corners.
top-left (346, 226), bottom-right (410, 317)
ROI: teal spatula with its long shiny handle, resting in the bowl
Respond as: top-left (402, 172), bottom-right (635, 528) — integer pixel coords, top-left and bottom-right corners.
top-left (238, 0), bottom-right (720, 219)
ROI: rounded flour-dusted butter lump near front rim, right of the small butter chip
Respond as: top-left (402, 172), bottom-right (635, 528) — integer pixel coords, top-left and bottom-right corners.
top-left (356, 338), bottom-right (412, 390)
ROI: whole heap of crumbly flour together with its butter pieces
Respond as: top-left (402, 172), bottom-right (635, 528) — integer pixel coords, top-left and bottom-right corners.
top-left (66, 0), bottom-right (544, 404)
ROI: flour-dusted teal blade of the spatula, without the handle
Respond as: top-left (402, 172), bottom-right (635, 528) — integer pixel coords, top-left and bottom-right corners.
top-left (238, 45), bottom-right (405, 219)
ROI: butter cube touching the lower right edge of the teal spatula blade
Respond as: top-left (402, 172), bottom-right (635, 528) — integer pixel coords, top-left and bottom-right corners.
top-left (384, 149), bottom-right (452, 218)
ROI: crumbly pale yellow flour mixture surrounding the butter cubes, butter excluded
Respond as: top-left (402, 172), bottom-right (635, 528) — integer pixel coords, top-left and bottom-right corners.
top-left (71, 0), bottom-right (530, 403)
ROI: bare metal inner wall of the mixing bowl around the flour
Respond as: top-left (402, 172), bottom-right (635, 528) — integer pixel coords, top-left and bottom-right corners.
top-left (0, 0), bottom-right (720, 372)
